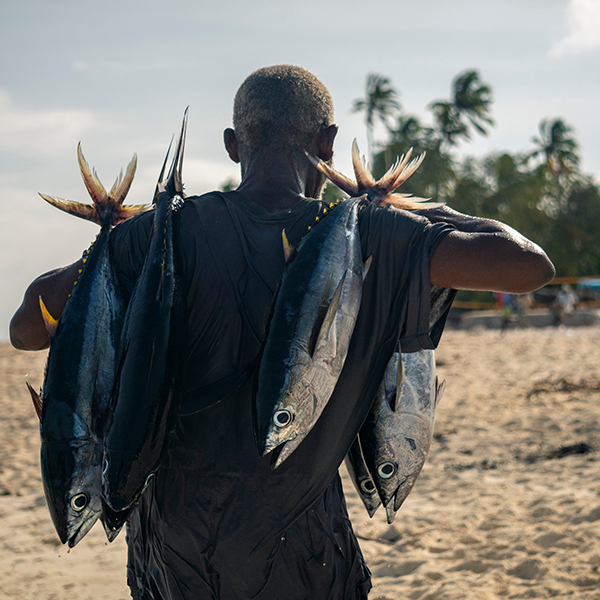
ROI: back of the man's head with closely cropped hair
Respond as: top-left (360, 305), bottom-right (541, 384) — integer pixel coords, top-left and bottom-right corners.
top-left (225, 65), bottom-right (336, 163)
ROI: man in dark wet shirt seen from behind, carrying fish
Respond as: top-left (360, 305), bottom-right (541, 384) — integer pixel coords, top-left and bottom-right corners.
top-left (11, 65), bottom-right (554, 600)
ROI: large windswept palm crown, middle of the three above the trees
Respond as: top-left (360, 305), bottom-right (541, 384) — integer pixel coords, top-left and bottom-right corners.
top-left (429, 71), bottom-right (494, 146)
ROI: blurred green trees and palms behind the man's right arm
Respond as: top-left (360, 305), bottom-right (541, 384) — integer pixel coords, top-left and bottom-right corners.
top-left (360, 71), bottom-right (600, 278)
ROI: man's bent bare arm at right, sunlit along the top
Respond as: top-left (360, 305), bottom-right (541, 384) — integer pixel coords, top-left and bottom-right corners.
top-left (418, 206), bottom-right (555, 294)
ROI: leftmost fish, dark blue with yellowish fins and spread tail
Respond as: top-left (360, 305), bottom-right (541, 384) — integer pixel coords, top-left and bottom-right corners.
top-left (27, 144), bottom-right (150, 548)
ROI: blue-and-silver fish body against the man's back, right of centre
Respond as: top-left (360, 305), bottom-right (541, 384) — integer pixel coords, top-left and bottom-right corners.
top-left (254, 199), bottom-right (371, 468)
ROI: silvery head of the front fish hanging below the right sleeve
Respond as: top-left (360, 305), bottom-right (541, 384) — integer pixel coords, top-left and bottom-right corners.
top-left (373, 413), bottom-right (432, 510)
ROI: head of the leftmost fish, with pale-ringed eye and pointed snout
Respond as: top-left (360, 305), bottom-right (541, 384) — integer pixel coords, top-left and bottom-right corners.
top-left (40, 440), bottom-right (103, 548)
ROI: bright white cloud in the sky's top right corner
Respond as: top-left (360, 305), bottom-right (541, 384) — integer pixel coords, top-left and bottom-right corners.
top-left (551, 0), bottom-right (600, 57)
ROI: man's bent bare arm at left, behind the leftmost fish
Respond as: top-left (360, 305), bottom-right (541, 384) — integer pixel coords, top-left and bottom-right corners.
top-left (10, 259), bottom-right (83, 350)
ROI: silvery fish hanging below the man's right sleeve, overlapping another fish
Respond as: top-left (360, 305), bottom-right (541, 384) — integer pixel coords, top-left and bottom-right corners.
top-left (359, 350), bottom-right (446, 523)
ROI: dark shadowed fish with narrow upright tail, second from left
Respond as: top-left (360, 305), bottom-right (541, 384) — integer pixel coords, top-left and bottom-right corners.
top-left (103, 109), bottom-right (187, 513)
